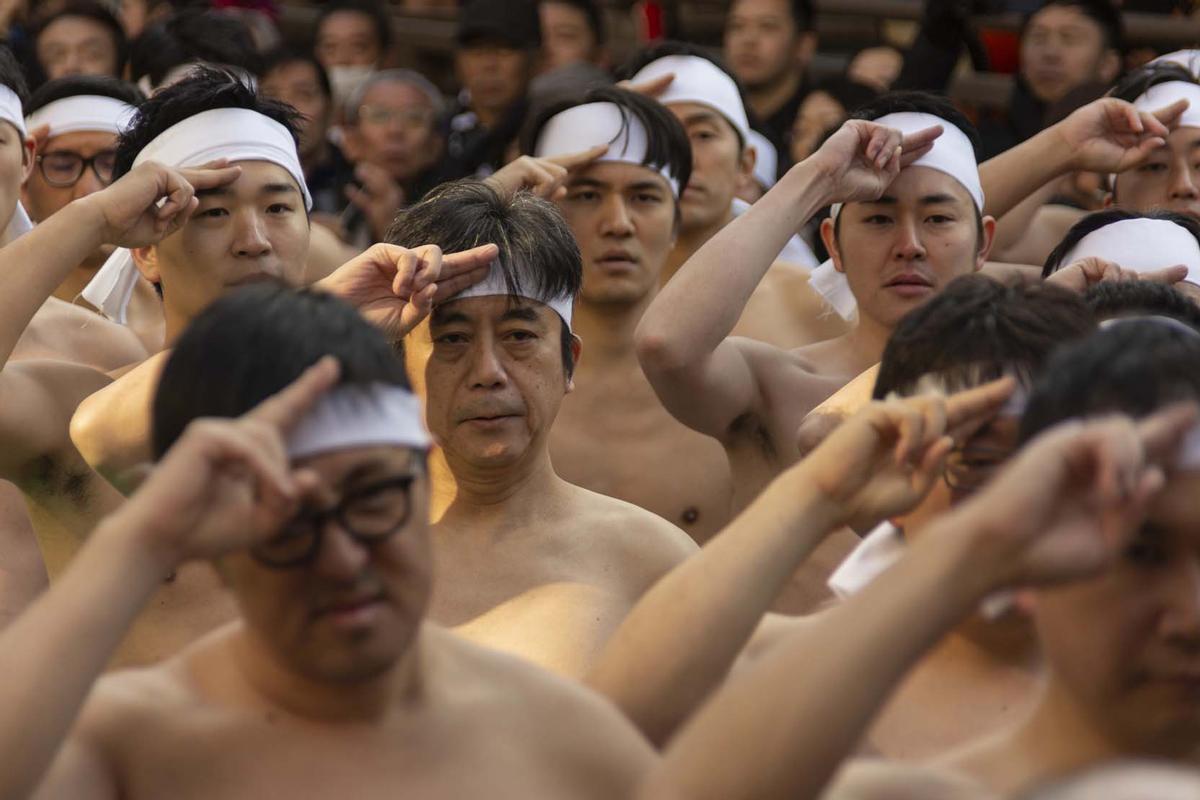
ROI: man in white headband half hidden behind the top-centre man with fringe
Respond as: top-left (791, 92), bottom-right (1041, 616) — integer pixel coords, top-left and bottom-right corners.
top-left (623, 42), bottom-right (846, 348)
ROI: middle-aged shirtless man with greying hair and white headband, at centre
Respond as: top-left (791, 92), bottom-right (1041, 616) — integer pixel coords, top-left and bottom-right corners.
top-left (388, 182), bottom-right (696, 676)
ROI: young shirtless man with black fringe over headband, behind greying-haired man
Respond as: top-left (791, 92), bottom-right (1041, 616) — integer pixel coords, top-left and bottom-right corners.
top-left (526, 89), bottom-right (731, 543)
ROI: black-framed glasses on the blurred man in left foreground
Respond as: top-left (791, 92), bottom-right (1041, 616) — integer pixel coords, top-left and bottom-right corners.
top-left (250, 475), bottom-right (415, 569)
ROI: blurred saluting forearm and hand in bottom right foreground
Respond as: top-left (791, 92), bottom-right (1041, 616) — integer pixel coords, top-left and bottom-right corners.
top-left (643, 408), bottom-right (1194, 800)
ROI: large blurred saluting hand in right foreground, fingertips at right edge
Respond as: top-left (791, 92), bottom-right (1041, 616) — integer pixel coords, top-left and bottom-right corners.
top-left (964, 404), bottom-right (1196, 588)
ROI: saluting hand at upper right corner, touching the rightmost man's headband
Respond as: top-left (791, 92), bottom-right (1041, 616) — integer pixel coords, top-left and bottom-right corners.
top-left (1055, 97), bottom-right (1188, 173)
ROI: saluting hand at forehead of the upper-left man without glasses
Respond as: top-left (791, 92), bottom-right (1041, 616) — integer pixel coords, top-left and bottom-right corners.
top-left (78, 161), bottom-right (241, 247)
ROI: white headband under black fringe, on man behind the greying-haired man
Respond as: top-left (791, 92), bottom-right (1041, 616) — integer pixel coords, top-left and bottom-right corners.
top-left (534, 103), bottom-right (679, 197)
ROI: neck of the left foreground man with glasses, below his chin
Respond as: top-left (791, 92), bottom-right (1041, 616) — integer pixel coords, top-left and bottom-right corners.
top-left (228, 625), bottom-right (426, 723)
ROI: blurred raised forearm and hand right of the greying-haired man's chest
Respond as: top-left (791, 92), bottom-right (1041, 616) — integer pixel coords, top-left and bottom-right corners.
top-left (588, 381), bottom-right (1010, 745)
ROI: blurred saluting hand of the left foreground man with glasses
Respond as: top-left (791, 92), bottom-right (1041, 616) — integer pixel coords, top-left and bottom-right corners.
top-left (114, 357), bottom-right (338, 571)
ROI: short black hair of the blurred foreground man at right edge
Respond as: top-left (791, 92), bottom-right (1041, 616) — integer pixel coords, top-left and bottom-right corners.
top-left (1020, 319), bottom-right (1200, 443)
